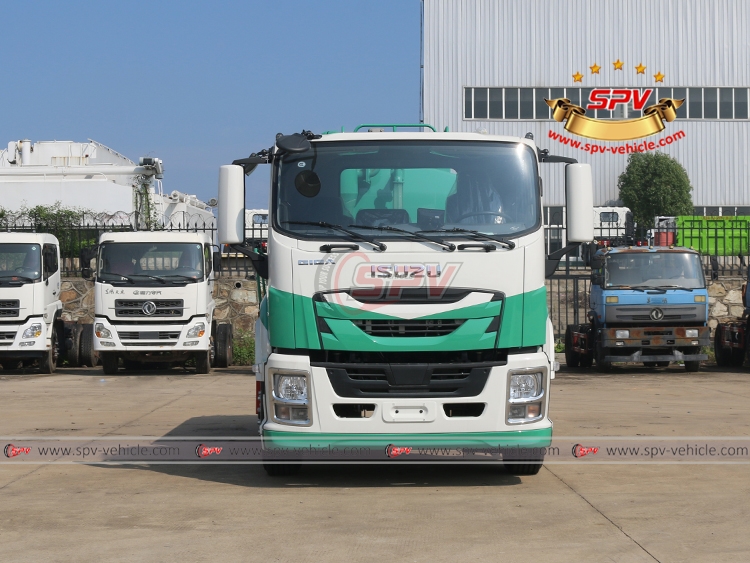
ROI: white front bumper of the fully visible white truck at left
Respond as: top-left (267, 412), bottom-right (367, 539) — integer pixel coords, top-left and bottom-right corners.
top-left (94, 317), bottom-right (211, 355)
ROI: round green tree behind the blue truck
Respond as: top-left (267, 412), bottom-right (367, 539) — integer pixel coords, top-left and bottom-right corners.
top-left (617, 151), bottom-right (693, 228)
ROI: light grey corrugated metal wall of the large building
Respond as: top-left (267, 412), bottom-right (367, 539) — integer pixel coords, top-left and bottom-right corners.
top-left (423, 0), bottom-right (750, 206)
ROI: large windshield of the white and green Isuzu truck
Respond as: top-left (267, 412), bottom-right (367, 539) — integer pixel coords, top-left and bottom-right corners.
top-left (273, 141), bottom-right (540, 238)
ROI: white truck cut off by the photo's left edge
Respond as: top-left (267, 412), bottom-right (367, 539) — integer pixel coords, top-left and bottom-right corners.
top-left (0, 233), bottom-right (64, 373)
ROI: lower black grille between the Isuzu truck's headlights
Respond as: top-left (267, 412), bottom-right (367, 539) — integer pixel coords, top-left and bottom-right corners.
top-left (322, 364), bottom-right (492, 398)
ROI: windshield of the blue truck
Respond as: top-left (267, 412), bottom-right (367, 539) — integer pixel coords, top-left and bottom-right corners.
top-left (605, 252), bottom-right (706, 289)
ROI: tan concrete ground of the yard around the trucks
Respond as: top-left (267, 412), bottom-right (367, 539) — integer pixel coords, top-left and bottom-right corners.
top-left (0, 367), bottom-right (750, 562)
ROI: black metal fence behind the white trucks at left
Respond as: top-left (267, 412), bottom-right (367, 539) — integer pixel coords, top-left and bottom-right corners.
top-left (0, 217), bottom-right (268, 279)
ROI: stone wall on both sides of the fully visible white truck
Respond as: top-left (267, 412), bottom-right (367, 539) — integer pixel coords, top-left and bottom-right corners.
top-left (60, 278), bottom-right (258, 330)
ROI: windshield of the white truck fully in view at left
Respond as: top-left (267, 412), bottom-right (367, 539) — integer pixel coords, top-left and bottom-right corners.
top-left (97, 242), bottom-right (203, 285)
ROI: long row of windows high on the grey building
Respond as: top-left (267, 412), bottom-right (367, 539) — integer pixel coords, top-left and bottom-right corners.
top-left (464, 87), bottom-right (748, 121)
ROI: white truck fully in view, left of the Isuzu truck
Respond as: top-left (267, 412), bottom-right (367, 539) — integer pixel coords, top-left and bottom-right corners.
top-left (82, 231), bottom-right (232, 374)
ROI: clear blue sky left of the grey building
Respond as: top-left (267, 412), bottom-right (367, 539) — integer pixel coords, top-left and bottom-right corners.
top-left (0, 0), bottom-right (420, 207)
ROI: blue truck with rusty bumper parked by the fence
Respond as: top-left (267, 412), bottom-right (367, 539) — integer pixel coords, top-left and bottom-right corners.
top-left (565, 246), bottom-right (710, 371)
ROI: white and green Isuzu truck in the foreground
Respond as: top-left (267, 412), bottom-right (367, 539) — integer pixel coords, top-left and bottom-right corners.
top-left (219, 125), bottom-right (593, 474)
